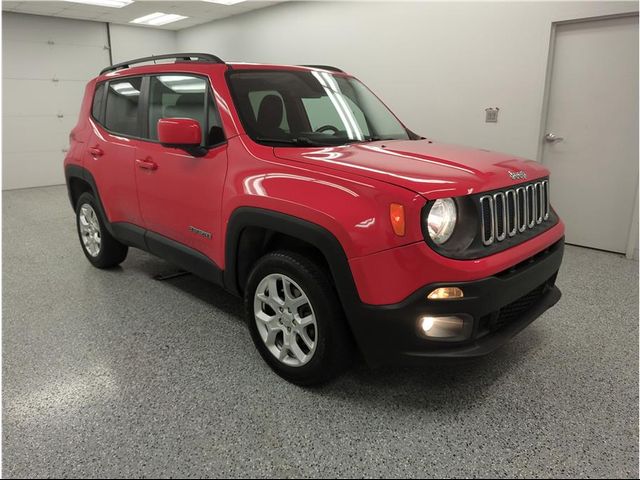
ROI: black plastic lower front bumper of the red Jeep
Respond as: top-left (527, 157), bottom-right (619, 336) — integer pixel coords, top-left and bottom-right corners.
top-left (349, 239), bottom-right (564, 366)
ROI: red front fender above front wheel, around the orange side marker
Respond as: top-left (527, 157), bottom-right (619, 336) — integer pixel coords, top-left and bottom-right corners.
top-left (223, 136), bottom-right (426, 259)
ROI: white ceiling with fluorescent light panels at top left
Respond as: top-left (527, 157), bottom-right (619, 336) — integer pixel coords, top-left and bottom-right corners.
top-left (2, 0), bottom-right (286, 30)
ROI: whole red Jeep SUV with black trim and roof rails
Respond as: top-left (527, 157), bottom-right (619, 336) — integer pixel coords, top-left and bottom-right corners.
top-left (65, 53), bottom-right (564, 384)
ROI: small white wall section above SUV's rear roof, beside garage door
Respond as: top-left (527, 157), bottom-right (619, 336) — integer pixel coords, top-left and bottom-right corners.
top-left (109, 23), bottom-right (177, 63)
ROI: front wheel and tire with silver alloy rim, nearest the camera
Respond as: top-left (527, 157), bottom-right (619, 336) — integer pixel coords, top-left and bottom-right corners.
top-left (244, 251), bottom-right (354, 385)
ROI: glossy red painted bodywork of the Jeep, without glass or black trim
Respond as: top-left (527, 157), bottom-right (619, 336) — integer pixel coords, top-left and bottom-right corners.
top-left (65, 62), bottom-right (564, 305)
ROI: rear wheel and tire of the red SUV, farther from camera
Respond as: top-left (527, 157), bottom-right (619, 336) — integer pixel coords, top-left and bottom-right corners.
top-left (76, 192), bottom-right (129, 268)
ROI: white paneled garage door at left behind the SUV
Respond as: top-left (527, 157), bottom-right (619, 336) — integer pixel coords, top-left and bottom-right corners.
top-left (2, 12), bottom-right (109, 190)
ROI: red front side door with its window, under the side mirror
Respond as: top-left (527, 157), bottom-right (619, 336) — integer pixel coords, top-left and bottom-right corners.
top-left (136, 74), bottom-right (227, 265)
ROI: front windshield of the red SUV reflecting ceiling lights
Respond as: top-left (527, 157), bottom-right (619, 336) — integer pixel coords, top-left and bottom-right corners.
top-left (229, 70), bottom-right (412, 146)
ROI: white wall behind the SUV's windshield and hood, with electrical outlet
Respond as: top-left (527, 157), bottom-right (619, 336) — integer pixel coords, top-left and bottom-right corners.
top-left (177, 1), bottom-right (638, 158)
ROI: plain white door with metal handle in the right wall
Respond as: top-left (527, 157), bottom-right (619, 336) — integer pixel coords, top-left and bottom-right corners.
top-left (542, 16), bottom-right (638, 252)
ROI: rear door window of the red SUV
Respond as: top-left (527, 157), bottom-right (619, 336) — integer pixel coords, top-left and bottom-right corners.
top-left (104, 78), bottom-right (142, 137)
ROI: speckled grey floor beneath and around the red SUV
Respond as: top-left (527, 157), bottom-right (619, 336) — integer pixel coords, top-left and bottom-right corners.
top-left (2, 187), bottom-right (638, 478)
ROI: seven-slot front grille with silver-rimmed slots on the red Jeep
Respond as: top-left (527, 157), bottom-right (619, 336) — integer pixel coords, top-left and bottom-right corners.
top-left (480, 180), bottom-right (551, 245)
